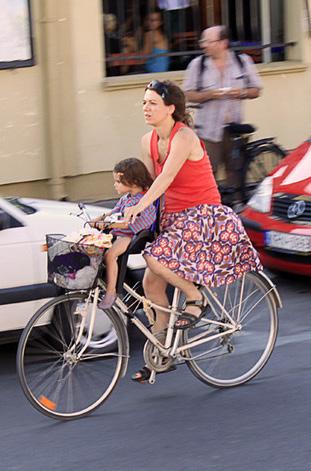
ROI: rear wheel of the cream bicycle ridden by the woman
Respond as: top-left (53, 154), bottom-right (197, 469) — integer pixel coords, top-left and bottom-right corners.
top-left (184, 272), bottom-right (278, 388)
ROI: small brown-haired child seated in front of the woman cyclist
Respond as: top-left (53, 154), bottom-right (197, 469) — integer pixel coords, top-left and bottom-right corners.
top-left (91, 158), bottom-right (156, 309)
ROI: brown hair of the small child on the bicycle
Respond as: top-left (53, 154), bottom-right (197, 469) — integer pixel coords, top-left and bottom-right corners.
top-left (113, 158), bottom-right (153, 190)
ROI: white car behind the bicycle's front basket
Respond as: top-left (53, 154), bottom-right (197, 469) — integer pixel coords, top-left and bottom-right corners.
top-left (0, 198), bottom-right (118, 345)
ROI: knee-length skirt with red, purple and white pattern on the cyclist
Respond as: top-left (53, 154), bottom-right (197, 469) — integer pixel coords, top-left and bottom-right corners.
top-left (144, 204), bottom-right (262, 287)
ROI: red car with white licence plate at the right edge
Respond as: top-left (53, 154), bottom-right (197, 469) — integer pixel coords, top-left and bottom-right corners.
top-left (240, 139), bottom-right (311, 276)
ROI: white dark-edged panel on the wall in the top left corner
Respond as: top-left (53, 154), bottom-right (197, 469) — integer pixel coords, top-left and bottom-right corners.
top-left (0, 0), bottom-right (34, 69)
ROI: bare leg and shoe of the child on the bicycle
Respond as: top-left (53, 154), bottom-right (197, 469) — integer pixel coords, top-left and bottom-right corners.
top-left (99, 237), bottom-right (131, 309)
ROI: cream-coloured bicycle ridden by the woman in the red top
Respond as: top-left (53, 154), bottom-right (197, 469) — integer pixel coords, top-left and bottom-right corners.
top-left (17, 205), bottom-right (282, 420)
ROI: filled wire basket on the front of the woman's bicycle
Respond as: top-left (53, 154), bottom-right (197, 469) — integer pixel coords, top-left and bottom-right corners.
top-left (46, 234), bottom-right (105, 290)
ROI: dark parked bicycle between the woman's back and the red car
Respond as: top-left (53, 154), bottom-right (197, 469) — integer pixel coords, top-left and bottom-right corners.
top-left (220, 123), bottom-right (287, 206)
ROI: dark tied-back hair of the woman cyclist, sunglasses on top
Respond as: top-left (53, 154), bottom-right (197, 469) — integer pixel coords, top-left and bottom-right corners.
top-left (146, 80), bottom-right (193, 127)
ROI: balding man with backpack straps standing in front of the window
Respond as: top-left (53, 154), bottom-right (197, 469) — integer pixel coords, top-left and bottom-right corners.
top-left (183, 25), bottom-right (261, 205)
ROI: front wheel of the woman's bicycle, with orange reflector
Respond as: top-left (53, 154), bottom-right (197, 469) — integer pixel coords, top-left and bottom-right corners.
top-left (17, 293), bottom-right (126, 420)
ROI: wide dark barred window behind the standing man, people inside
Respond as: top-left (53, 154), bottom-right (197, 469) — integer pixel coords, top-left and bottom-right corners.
top-left (103, 0), bottom-right (287, 76)
